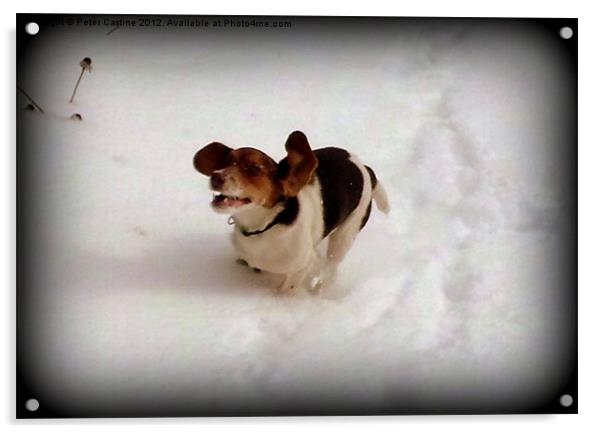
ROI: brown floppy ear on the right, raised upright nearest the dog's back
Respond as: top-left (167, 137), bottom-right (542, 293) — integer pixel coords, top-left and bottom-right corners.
top-left (278, 131), bottom-right (318, 197)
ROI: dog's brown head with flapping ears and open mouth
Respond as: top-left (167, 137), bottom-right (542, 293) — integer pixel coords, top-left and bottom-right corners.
top-left (193, 131), bottom-right (318, 214)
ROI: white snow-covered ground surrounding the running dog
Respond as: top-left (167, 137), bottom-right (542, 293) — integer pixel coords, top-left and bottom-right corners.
top-left (21, 22), bottom-right (573, 411)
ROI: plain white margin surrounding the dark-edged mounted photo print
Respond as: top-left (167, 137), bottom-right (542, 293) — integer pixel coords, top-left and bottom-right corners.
top-left (0, 0), bottom-right (602, 433)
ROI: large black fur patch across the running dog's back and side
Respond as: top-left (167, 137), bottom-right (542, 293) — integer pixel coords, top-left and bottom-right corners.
top-left (314, 147), bottom-right (364, 237)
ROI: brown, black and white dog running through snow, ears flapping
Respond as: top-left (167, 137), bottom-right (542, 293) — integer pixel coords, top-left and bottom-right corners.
top-left (194, 131), bottom-right (389, 292)
